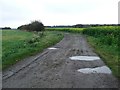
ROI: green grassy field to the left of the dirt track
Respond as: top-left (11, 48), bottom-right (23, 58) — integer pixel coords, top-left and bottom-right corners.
top-left (2, 30), bottom-right (63, 69)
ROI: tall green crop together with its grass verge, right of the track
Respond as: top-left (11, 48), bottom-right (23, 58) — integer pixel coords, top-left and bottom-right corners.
top-left (83, 26), bottom-right (120, 78)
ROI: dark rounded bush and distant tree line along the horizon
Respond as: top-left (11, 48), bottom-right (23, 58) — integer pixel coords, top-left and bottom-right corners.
top-left (0, 21), bottom-right (120, 31)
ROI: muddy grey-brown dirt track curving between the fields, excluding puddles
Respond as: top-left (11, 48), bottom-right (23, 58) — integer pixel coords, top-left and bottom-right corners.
top-left (3, 34), bottom-right (118, 88)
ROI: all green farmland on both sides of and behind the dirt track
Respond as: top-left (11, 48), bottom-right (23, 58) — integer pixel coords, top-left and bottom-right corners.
top-left (2, 26), bottom-right (120, 77)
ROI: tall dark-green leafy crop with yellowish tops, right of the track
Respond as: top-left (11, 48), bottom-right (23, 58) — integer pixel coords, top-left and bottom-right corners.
top-left (83, 26), bottom-right (120, 45)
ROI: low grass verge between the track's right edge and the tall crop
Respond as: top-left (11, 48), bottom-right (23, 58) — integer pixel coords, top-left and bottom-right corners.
top-left (87, 36), bottom-right (120, 79)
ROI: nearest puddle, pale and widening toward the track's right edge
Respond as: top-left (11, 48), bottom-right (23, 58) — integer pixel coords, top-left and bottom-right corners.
top-left (77, 66), bottom-right (112, 74)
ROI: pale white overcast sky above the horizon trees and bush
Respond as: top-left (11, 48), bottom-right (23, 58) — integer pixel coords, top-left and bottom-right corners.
top-left (0, 0), bottom-right (119, 28)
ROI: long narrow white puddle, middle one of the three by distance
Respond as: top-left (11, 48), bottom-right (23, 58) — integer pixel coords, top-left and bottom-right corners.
top-left (70, 56), bottom-right (100, 61)
